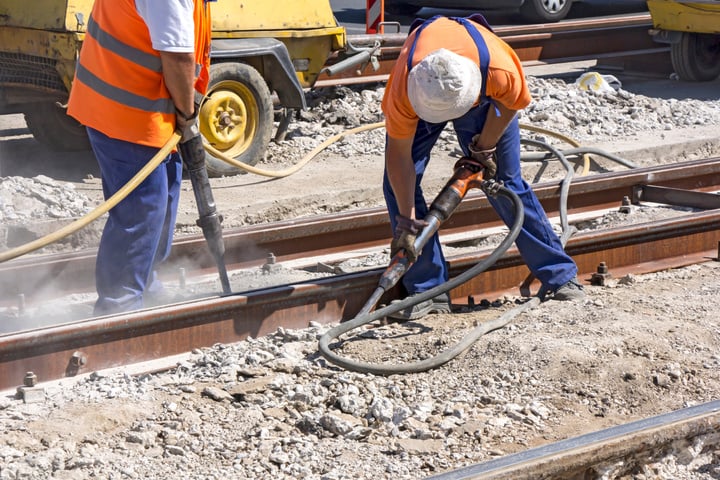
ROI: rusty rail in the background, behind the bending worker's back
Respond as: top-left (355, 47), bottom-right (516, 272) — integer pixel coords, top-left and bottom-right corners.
top-left (314, 13), bottom-right (672, 87)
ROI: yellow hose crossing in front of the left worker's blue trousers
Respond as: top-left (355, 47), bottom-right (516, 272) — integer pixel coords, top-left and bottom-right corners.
top-left (0, 132), bottom-right (180, 263)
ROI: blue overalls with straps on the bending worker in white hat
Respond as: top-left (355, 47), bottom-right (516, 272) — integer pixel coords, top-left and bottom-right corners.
top-left (383, 15), bottom-right (577, 295)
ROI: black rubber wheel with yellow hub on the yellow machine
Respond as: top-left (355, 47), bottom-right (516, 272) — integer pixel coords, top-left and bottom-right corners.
top-left (199, 63), bottom-right (273, 177)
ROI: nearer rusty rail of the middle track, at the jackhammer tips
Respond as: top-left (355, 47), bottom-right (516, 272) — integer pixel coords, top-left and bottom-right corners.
top-left (0, 205), bottom-right (720, 390)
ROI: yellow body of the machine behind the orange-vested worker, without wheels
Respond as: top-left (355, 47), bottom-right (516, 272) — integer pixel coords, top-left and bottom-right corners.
top-left (0, 0), bottom-right (346, 97)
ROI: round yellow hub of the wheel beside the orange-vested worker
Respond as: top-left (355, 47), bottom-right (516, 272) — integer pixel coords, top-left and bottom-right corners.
top-left (200, 81), bottom-right (258, 157)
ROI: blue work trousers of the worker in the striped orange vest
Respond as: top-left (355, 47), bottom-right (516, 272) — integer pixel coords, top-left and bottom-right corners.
top-left (87, 128), bottom-right (182, 315)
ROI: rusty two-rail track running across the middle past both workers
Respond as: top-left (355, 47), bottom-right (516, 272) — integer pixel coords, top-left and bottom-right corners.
top-left (0, 158), bottom-right (720, 390)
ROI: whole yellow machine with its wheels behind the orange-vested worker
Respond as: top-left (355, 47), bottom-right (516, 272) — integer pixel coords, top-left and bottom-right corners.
top-left (0, 0), bottom-right (346, 176)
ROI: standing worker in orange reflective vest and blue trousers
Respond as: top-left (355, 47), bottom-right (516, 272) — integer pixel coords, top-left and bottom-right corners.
top-left (68, 0), bottom-right (214, 315)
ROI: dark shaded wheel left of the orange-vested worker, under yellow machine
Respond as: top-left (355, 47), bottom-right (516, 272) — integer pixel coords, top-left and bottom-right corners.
top-left (24, 102), bottom-right (90, 152)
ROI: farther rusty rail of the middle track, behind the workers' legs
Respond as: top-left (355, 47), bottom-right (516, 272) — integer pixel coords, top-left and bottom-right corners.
top-left (0, 158), bottom-right (720, 304)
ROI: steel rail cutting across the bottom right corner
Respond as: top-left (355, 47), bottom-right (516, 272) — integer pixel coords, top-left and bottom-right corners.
top-left (427, 401), bottom-right (720, 480)
